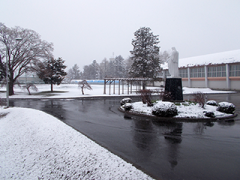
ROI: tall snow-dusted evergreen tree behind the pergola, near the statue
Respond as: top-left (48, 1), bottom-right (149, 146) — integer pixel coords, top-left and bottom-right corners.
top-left (129, 27), bottom-right (160, 78)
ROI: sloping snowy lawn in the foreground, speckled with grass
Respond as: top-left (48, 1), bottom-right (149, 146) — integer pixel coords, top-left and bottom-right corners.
top-left (0, 108), bottom-right (151, 179)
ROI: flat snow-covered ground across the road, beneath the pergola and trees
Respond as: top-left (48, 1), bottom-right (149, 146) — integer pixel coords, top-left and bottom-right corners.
top-left (0, 84), bottom-right (233, 98)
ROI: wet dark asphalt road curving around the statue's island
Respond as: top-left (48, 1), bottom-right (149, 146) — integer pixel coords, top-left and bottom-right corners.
top-left (10, 94), bottom-right (240, 180)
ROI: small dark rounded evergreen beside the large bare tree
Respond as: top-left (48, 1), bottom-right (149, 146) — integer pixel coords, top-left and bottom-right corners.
top-left (37, 58), bottom-right (67, 92)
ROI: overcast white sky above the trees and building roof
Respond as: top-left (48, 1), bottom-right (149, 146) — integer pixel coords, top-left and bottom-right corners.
top-left (0, 0), bottom-right (240, 69)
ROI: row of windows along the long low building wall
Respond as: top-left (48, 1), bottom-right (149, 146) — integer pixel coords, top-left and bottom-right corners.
top-left (179, 64), bottom-right (240, 78)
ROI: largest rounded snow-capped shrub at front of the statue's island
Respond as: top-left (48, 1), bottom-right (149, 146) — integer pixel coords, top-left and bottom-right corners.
top-left (152, 101), bottom-right (178, 117)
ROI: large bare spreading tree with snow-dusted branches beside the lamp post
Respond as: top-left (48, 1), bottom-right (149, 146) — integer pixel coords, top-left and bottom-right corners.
top-left (0, 23), bottom-right (53, 95)
